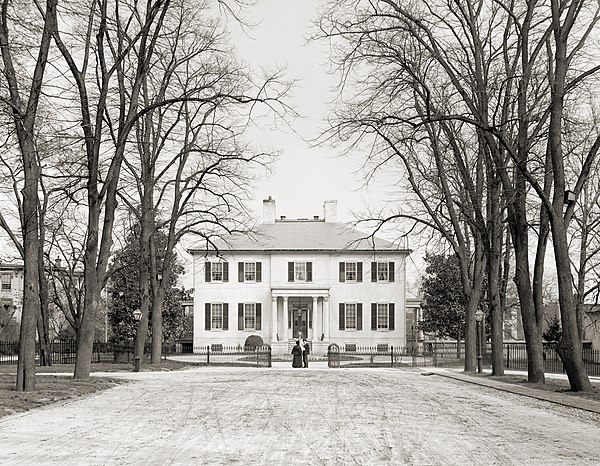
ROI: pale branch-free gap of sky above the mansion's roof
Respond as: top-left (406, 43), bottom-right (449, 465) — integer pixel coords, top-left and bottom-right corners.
top-left (228, 0), bottom-right (390, 222)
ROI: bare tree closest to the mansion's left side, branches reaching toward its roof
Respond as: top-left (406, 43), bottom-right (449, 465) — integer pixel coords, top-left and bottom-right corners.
top-left (121, 1), bottom-right (288, 363)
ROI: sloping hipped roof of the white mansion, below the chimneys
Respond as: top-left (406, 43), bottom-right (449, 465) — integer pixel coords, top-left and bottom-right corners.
top-left (190, 220), bottom-right (410, 253)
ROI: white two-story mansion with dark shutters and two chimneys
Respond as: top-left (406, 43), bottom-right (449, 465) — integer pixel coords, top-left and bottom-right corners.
top-left (190, 197), bottom-right (410, 354)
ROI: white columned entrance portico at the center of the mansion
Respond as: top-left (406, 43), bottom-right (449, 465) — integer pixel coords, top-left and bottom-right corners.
top-left (271, 287), bottom-right (330, 354)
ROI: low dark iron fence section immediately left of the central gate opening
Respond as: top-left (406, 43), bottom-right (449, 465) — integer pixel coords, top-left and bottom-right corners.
top-left (194, 345), bottom-right (272, 367)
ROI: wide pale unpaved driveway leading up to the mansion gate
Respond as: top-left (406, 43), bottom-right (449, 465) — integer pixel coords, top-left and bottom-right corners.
top-left (0, 365), bottom-right (600, 466)
